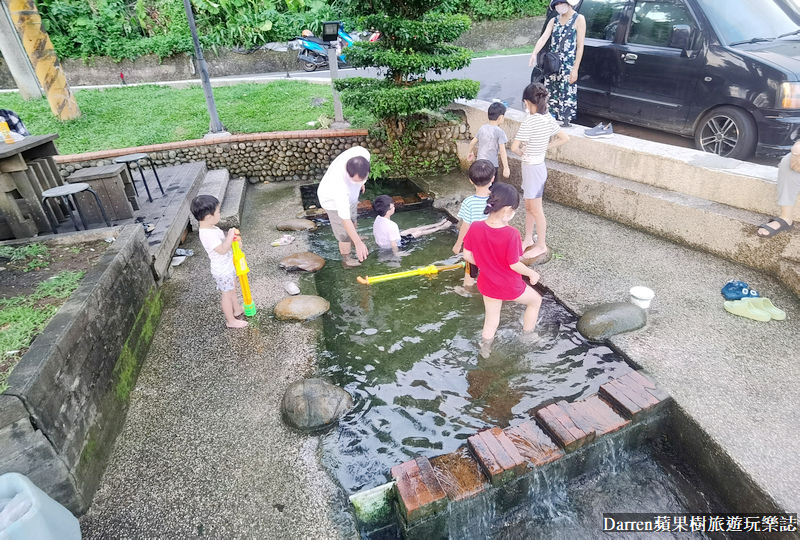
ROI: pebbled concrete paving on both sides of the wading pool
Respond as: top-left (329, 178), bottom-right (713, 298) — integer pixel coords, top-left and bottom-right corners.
top-left (81, 175), bottom-right (800, 539)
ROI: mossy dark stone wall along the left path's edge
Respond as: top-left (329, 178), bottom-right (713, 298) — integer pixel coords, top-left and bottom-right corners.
top-left (0, 225), bottom-right (161, 513)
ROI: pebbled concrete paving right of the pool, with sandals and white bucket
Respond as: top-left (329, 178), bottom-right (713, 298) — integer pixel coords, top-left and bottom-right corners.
top-left (428, 173), bottom-right (800, 512)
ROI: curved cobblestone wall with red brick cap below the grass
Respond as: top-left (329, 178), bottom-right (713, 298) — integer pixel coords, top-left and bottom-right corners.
top-left (56, 123), bottom-right (470, 183)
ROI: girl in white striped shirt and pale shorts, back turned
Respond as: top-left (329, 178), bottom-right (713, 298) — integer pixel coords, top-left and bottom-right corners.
top-left (511, 83), bottom-right (569, 258)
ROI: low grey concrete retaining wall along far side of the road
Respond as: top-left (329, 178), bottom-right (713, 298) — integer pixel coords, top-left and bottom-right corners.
top-left (0, 17), bottom-right (544, 88)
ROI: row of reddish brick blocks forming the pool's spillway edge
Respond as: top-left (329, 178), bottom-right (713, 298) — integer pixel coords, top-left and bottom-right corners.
top-left (350, 371), bottom-right (670, 538)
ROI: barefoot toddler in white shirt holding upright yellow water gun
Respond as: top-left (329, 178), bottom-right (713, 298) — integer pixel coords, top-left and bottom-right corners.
top-left (191, 195), bottom-right (247, 328)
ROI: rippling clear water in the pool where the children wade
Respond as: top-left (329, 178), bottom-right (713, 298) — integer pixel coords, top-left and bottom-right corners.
top-left (311, 209), bottom-right (631, 493)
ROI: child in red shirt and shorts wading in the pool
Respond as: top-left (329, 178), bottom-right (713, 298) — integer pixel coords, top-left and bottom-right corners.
top-left (464, 184), bottom-right (542, 358)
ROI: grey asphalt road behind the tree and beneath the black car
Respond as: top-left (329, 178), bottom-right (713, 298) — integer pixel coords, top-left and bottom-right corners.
top-left (260, 53), bottom-right (778, 166)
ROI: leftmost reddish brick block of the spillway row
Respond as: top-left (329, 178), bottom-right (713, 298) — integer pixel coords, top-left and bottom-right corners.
top-left (391, 457), bottom-right (448, 524)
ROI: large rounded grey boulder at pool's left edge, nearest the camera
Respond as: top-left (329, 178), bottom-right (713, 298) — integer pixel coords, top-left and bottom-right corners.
top-left (281, 379), bottom-right (353, 431)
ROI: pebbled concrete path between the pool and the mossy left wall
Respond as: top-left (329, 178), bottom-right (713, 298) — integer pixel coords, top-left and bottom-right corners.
top-left (81, 184), bottom-right (352, 539)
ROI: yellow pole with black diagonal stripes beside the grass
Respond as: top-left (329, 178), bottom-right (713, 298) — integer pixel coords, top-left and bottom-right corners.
top-left (5, 0), bottom-right (81, 120)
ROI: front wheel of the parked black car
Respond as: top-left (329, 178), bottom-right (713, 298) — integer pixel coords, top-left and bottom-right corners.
top-left (694, 107), bottom-right (758, 159)
